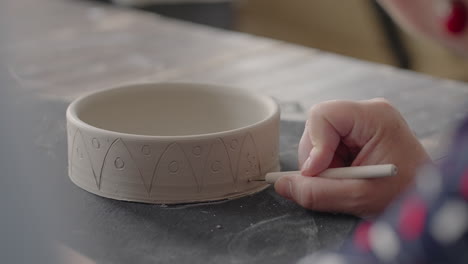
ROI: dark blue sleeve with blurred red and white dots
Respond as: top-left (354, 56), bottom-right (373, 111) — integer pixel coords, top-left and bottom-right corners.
top-left (300, 120), bottom-right (468, 264)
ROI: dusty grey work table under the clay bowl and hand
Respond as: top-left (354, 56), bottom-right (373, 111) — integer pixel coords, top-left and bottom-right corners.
top-left (0, 0), bottom-right (468, 263)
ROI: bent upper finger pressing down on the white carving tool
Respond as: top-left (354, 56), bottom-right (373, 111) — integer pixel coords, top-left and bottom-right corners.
top-left (299, 101), bottom-right (373, 176)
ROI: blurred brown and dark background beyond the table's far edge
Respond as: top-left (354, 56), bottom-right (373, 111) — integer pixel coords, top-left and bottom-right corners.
top-left (96, 0), bottom-right (468, 81)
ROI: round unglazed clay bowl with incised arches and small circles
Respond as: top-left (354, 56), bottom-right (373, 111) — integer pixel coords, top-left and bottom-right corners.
top-left (67, 83), bottom-right (280, 204)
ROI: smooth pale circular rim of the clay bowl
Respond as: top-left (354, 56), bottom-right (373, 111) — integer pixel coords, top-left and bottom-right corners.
top-left (66, 81), bottom-right (280, 141)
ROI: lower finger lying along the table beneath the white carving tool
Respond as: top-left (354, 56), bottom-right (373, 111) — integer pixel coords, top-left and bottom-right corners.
top-left (275, 175), bottom-right (391, 216)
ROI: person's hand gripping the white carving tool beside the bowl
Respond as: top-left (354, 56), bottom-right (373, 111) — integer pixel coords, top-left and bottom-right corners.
top-left (275, 99), bottom-right (429, 217)
